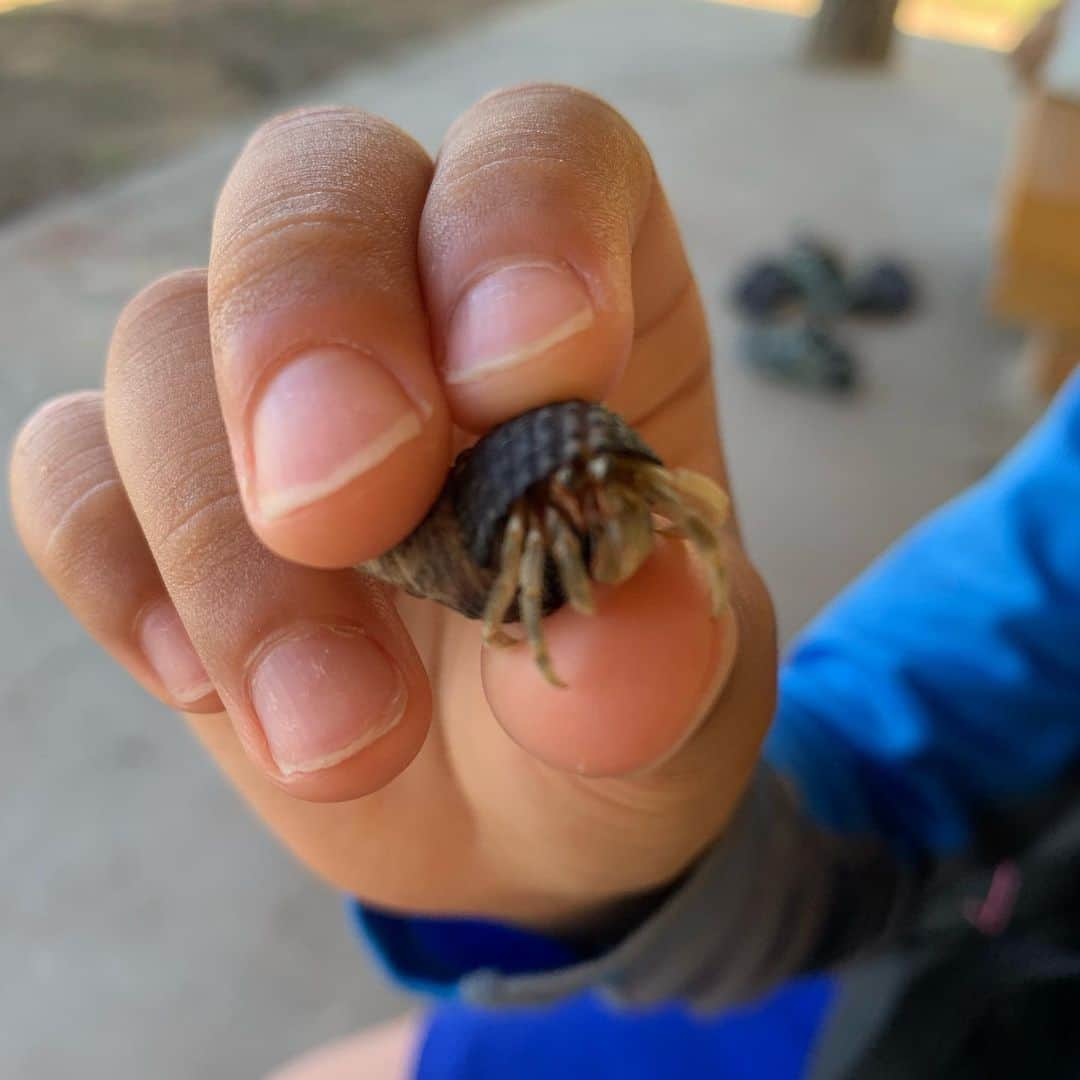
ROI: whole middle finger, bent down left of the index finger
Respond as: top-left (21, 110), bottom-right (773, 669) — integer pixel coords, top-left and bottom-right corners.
top-left (210, 108), bottom-right (450, 567)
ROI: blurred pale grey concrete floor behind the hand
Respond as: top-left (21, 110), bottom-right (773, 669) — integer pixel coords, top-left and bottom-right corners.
top-left (0, 0), bottom-right (1016, 1080)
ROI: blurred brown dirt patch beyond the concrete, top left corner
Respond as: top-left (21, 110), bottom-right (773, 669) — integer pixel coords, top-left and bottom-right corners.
top-left (0, 0), bottom-right (522, 219)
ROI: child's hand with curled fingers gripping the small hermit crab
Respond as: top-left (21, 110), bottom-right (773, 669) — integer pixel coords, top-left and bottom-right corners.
top-left (12, 85), bottom-right (774, 927)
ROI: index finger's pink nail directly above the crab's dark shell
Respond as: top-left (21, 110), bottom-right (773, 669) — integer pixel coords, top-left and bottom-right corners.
top-left (445, 260), bottom-right (595, 382)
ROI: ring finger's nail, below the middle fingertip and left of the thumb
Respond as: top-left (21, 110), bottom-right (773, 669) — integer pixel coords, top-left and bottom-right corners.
top-left (252, 626), bottom-right (407, 777)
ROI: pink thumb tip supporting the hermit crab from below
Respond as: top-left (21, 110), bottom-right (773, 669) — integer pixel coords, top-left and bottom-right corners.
top-left (483, 540), bottom-right (740, 777)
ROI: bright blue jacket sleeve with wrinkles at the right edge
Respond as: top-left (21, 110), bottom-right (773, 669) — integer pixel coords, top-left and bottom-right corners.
top-left (767, 376), bottom-right (1080, 855)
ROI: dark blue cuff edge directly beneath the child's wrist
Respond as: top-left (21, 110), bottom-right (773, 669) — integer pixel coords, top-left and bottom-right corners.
top-left (348, 899), bottom-right (588, 998)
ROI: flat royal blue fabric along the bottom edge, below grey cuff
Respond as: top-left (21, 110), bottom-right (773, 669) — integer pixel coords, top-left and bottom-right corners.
top-left (416, 978), bottom-right (835, 1080)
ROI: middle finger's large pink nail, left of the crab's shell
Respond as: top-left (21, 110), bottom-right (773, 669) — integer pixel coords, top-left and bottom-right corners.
top-left (252, 346), bottom-right (422, 518)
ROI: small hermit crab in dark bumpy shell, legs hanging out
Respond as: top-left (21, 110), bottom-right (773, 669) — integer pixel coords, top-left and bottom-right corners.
top-left (361, 401), bottom-right (728, 686)
